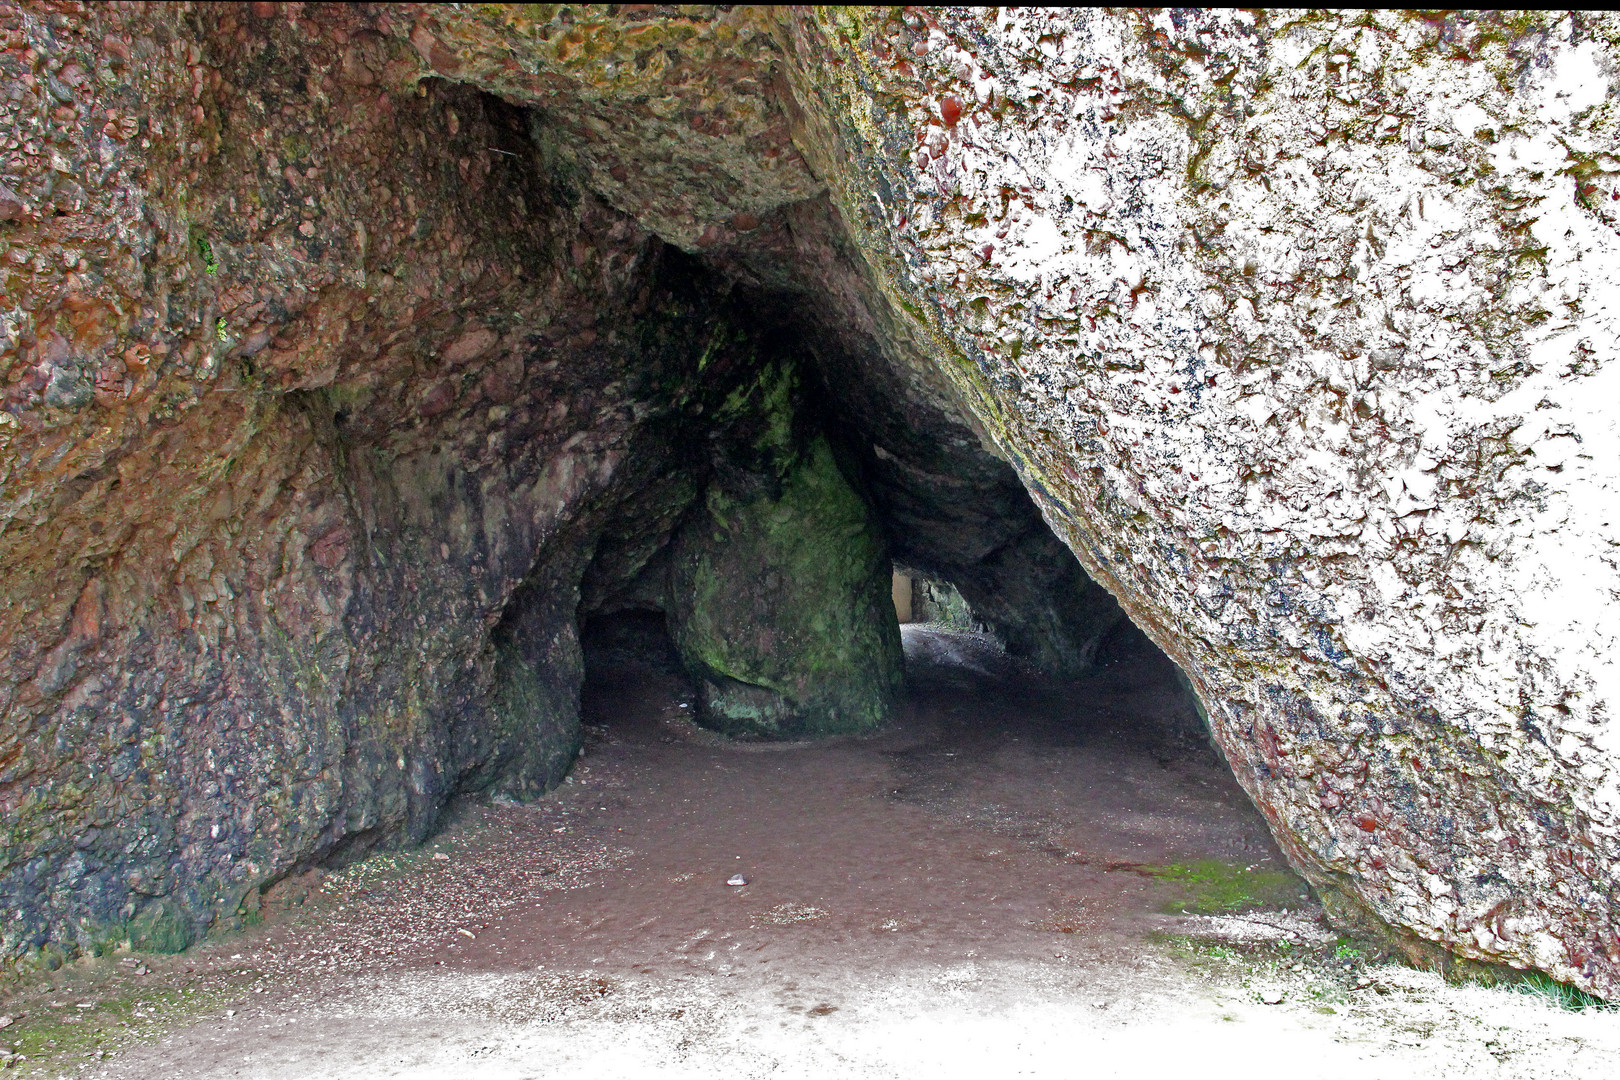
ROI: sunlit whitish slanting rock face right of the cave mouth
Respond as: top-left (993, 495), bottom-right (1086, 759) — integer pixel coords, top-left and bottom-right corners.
top-left (789, 8), bottom-right (1620, 993)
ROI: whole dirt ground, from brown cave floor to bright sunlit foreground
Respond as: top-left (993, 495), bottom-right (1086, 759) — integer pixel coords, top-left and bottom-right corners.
top-left (0, 627), bottom-right (1620, 1080)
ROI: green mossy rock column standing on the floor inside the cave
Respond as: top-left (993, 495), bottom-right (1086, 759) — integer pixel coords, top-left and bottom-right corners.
top-left (671, 439), bottom-right (904, 738)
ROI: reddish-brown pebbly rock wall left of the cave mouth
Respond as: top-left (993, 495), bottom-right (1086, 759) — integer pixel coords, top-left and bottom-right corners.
top-left (0, 5), bottom-right (887, 963)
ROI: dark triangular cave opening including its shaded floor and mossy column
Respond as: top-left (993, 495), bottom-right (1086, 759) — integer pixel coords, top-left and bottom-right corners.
top-left (554, 250), bottom-right (1301, 980)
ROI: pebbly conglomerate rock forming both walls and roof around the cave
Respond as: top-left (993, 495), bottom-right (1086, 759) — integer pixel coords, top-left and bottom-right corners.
top-left (0, 3), bottom-right (1620, 994)
